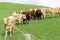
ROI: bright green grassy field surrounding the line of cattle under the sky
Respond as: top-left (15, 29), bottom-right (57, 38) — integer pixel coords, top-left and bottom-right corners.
top-left (0, 2), bottom-right (60, 40)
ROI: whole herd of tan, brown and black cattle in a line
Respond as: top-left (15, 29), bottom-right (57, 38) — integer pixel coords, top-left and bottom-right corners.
top-left (3, 8), bottom-right (60, 37)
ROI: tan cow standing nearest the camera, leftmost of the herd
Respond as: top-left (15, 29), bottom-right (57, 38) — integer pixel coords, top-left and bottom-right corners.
top-left (3, 16), bottom-right (16, 37)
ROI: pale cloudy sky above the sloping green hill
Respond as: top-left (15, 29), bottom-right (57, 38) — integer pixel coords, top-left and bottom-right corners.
top-left (0, 0), bottom-right (60, 8)
